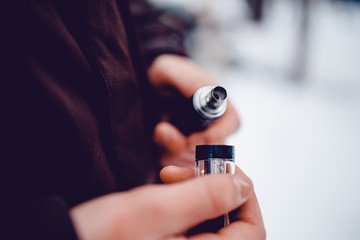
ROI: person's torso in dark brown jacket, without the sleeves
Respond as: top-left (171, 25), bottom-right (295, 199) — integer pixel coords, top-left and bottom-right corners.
top-left (3, 0), bottom-right (156, 204)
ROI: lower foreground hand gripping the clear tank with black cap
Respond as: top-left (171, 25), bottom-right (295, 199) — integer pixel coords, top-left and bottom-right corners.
top-left (70, 167), bottom-right (265, 240)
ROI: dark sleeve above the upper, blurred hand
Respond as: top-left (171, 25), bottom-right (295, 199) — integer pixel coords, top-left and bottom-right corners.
top-left (130, 0), bottom-right (194, 65)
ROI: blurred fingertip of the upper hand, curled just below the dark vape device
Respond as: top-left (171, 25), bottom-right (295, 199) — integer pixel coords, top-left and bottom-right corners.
top-left (154, 122), bottom-right (188, 153)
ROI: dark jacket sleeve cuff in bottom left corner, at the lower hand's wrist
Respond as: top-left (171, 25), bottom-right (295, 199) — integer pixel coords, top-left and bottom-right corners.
top-left (1, 197), bottom-right (77, 240)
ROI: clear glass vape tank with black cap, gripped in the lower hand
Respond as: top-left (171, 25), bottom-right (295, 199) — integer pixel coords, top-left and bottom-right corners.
top-left (195, 145), bottom-right (235, 230)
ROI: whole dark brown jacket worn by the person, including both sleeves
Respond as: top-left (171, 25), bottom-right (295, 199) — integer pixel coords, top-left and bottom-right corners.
top-left (1, 0), bottom-right (188, 239)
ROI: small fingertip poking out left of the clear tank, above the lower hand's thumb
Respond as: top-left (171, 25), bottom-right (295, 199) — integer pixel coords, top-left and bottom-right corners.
top-left (160, 166), bottom-right (195, 183)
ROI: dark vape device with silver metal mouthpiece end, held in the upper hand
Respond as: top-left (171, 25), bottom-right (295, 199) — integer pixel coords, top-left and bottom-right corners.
top-left (170, 86), bottom-right (227, 135)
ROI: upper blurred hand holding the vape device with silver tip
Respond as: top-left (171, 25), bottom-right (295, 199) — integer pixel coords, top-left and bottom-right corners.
top-left (148, 54), bottom-right (240, 167)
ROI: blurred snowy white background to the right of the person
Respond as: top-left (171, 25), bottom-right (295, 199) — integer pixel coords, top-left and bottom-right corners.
top-left (152, 0), bottom-right (360, 240)
